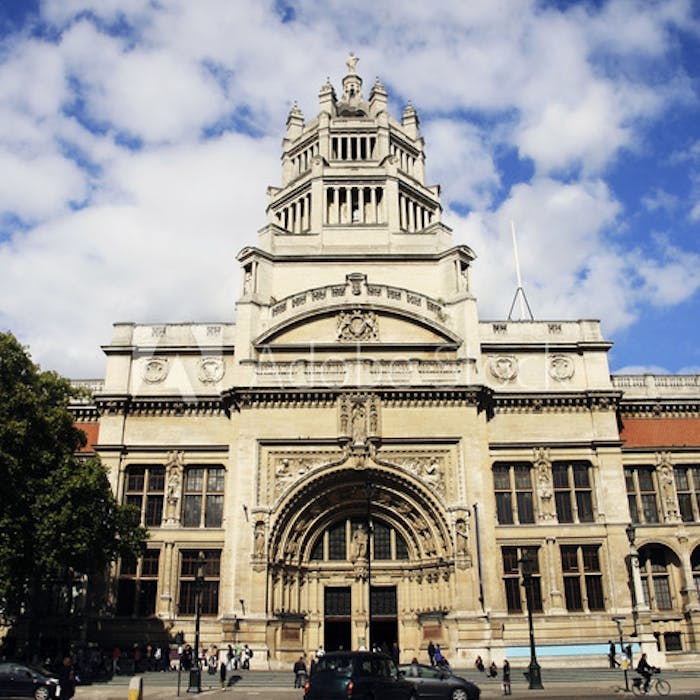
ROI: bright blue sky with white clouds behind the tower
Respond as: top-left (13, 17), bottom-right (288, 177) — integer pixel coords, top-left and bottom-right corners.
top-left (0, 0), bottom-right (700, 378)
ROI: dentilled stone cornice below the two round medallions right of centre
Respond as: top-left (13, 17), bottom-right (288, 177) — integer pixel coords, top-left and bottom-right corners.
top-left (493, 391), bottom-right (622, 413)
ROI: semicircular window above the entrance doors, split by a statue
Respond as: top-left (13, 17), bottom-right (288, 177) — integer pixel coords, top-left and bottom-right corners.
top-left (309, 518), bottom-right (408, 561)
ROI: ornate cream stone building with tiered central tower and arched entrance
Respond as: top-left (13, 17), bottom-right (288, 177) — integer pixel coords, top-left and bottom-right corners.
top-left (76, 56), bottom-right (700, 668)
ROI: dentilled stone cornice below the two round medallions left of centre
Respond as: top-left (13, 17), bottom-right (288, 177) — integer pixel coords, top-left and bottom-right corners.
top-left (95, 394), bottom-right (226, 416)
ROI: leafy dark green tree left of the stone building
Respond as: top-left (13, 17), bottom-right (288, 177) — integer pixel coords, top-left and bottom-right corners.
top-left (0, 333), bottom-right (147, 622)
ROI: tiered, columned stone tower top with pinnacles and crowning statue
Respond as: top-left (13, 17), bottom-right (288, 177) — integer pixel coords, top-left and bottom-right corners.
top-left (261, 54), bottom-right (450, 252)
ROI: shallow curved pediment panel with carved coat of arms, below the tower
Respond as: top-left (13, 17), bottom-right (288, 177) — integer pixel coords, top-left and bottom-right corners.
top-left (254, 304), bottom-right (461, 350)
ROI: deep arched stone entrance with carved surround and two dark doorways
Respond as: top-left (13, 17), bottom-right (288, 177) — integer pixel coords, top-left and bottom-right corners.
top-left (268, 465), bottom-right (454, 653)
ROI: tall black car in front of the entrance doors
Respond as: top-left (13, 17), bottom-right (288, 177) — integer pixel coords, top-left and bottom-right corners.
top-left (304, 651), bottom-right (418, 700)
